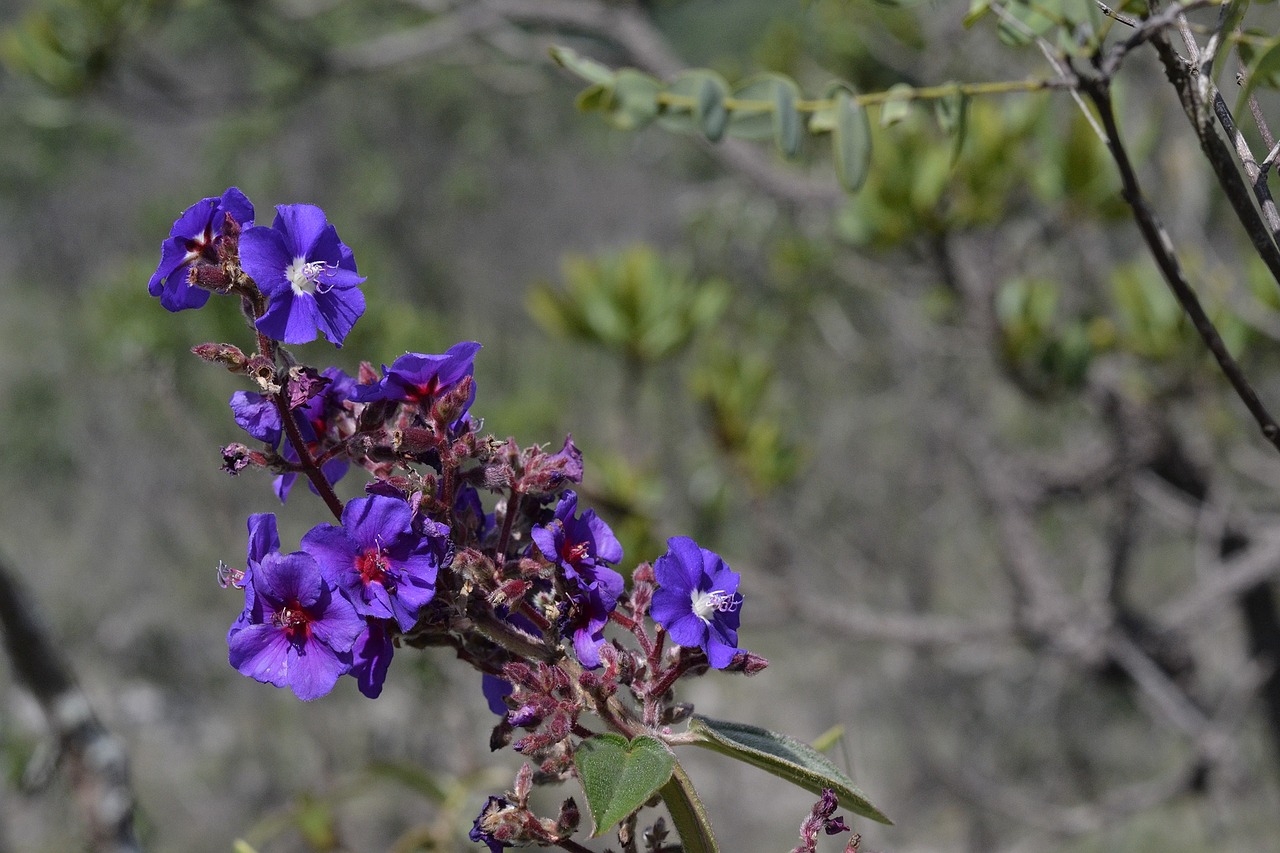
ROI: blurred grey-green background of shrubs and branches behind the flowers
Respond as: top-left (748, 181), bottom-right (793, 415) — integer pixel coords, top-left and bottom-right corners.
top-left (0, 0), bottom-right (1280, 853)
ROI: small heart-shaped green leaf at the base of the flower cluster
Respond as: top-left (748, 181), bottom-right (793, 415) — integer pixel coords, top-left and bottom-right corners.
top-left (573, 733), bottom-right (676, 838)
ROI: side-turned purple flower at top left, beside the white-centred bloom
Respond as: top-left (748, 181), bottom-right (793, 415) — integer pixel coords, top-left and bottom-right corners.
top-left (147, 187), bottom-right (253, 311)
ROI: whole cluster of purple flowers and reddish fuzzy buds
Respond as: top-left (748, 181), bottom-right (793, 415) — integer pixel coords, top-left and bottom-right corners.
top-left (148, 187), bottom-right (765, 849)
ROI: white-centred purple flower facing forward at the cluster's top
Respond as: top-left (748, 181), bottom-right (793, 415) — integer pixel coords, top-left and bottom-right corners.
top-left (239, 205), bottom-right (365, 347)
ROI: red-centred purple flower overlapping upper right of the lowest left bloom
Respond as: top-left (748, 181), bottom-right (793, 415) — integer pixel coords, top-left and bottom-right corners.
top-left (302, 494), bottom-right (448, 631)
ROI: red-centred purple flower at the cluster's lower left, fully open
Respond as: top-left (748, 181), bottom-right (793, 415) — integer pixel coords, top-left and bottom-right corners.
top-left (227, 545), bottom-right (366, 701)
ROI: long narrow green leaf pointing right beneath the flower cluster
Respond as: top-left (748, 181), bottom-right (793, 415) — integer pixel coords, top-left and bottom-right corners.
top-left (689, 715), bottom-right (893, 824)
